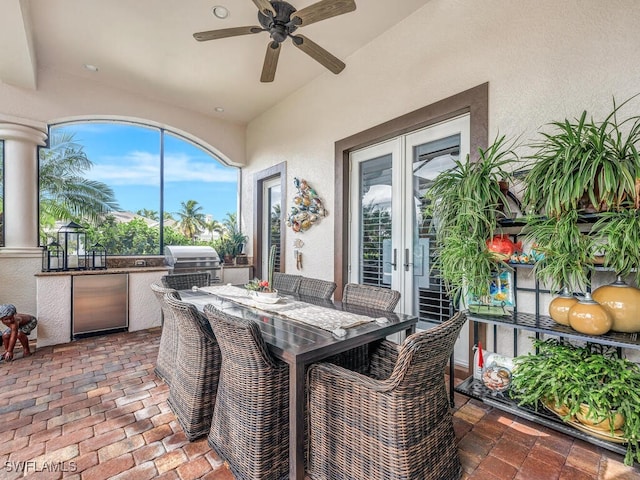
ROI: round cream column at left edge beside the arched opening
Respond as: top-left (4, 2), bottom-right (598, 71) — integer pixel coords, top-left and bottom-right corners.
top-left (0, 123), bottom-right (47, 255)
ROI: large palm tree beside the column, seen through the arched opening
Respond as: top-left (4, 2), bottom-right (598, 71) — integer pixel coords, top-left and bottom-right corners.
top-left (40, 132), bottom-right (119, 234)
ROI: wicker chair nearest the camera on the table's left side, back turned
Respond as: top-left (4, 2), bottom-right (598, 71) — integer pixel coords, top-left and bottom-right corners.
top-left (204, 305), bottom-right (289, 480)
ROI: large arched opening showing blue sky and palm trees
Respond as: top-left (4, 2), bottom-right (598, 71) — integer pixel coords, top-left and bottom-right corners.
top-left (39, 121), bottom-right (238, 256)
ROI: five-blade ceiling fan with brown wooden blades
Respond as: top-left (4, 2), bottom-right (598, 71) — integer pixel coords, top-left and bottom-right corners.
top-left (193, 0), bottom-right (356, 82)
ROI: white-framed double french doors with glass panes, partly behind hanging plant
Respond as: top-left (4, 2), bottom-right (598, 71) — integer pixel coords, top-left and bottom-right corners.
top-left (349, 114), bottom-right (469, 358)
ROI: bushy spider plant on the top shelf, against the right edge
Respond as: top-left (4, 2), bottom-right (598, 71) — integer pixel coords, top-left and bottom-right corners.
top-left (523, 97), bottom-right (640, 216)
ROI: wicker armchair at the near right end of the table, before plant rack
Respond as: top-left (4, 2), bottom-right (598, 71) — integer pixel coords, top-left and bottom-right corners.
top-left (307, 313), bottom-right (466, 480)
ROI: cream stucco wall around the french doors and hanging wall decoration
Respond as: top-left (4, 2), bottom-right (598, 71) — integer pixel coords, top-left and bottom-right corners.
top-left (243, 0), bottom-right (640, 360)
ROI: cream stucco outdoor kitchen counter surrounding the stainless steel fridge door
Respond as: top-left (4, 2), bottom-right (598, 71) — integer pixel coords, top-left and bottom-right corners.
top-left (32, 266), bottom-right (167, 347)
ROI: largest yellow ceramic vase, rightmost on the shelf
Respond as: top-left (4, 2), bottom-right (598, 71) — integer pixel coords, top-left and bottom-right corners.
top-left (591, 277), bottom-right (640, 333)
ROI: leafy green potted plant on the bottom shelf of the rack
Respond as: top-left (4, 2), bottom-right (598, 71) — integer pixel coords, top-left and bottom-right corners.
top-left (509, 338), bottom-right (640, 465)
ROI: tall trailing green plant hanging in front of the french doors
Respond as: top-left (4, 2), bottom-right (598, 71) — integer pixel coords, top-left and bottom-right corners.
top-left (425, 136), bottom-right (517, 308)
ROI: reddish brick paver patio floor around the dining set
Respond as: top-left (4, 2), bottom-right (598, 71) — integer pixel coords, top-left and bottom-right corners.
top-left (0, 329), bottom-right (640, 480)
